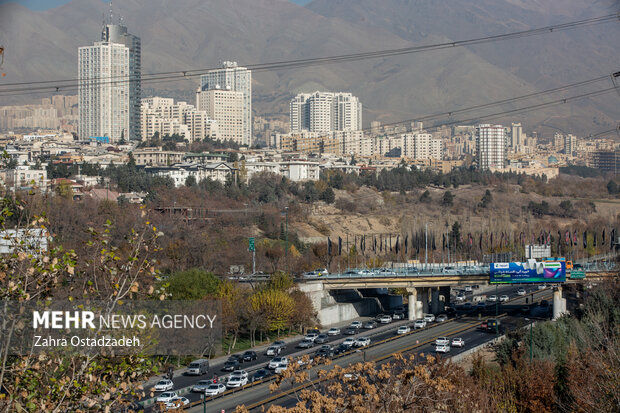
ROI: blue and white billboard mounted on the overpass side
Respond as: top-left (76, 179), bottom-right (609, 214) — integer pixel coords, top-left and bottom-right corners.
top-left (489, 259), bottom-right (566, 284)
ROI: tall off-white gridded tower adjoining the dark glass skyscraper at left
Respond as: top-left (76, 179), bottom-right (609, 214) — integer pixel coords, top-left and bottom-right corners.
top-left (78, 42), bottom-right (130, 142)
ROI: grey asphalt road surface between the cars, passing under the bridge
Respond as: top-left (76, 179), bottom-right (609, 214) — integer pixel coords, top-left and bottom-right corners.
top-left (143, 285), bottom-right (551, 412)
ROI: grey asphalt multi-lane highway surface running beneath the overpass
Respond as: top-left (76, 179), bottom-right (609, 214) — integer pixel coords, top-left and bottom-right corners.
top-left (147, 286), bottom-right (551, 413)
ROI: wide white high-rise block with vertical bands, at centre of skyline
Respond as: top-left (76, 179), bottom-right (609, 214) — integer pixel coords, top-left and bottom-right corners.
top-left (290, 91), bottom-right (362, 133)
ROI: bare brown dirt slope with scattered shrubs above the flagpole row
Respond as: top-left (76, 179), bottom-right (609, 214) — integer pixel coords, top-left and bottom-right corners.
top-left (291, 185), bottom-right (620, 242)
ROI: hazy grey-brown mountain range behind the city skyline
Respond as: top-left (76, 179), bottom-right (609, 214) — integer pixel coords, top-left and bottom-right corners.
top-left (0, 0), bottom-right (620, 134)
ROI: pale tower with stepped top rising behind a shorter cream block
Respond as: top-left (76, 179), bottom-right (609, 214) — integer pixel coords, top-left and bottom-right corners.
top-left (200, 61), bottom-right (252, 146)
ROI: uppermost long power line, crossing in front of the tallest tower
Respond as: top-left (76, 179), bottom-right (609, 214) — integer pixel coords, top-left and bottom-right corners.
top-left (0, 13), bottom-right (620, 94)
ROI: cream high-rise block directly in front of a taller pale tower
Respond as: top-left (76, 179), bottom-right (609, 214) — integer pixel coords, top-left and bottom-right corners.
top-left (196, 89), bottom-right (247, 145)
